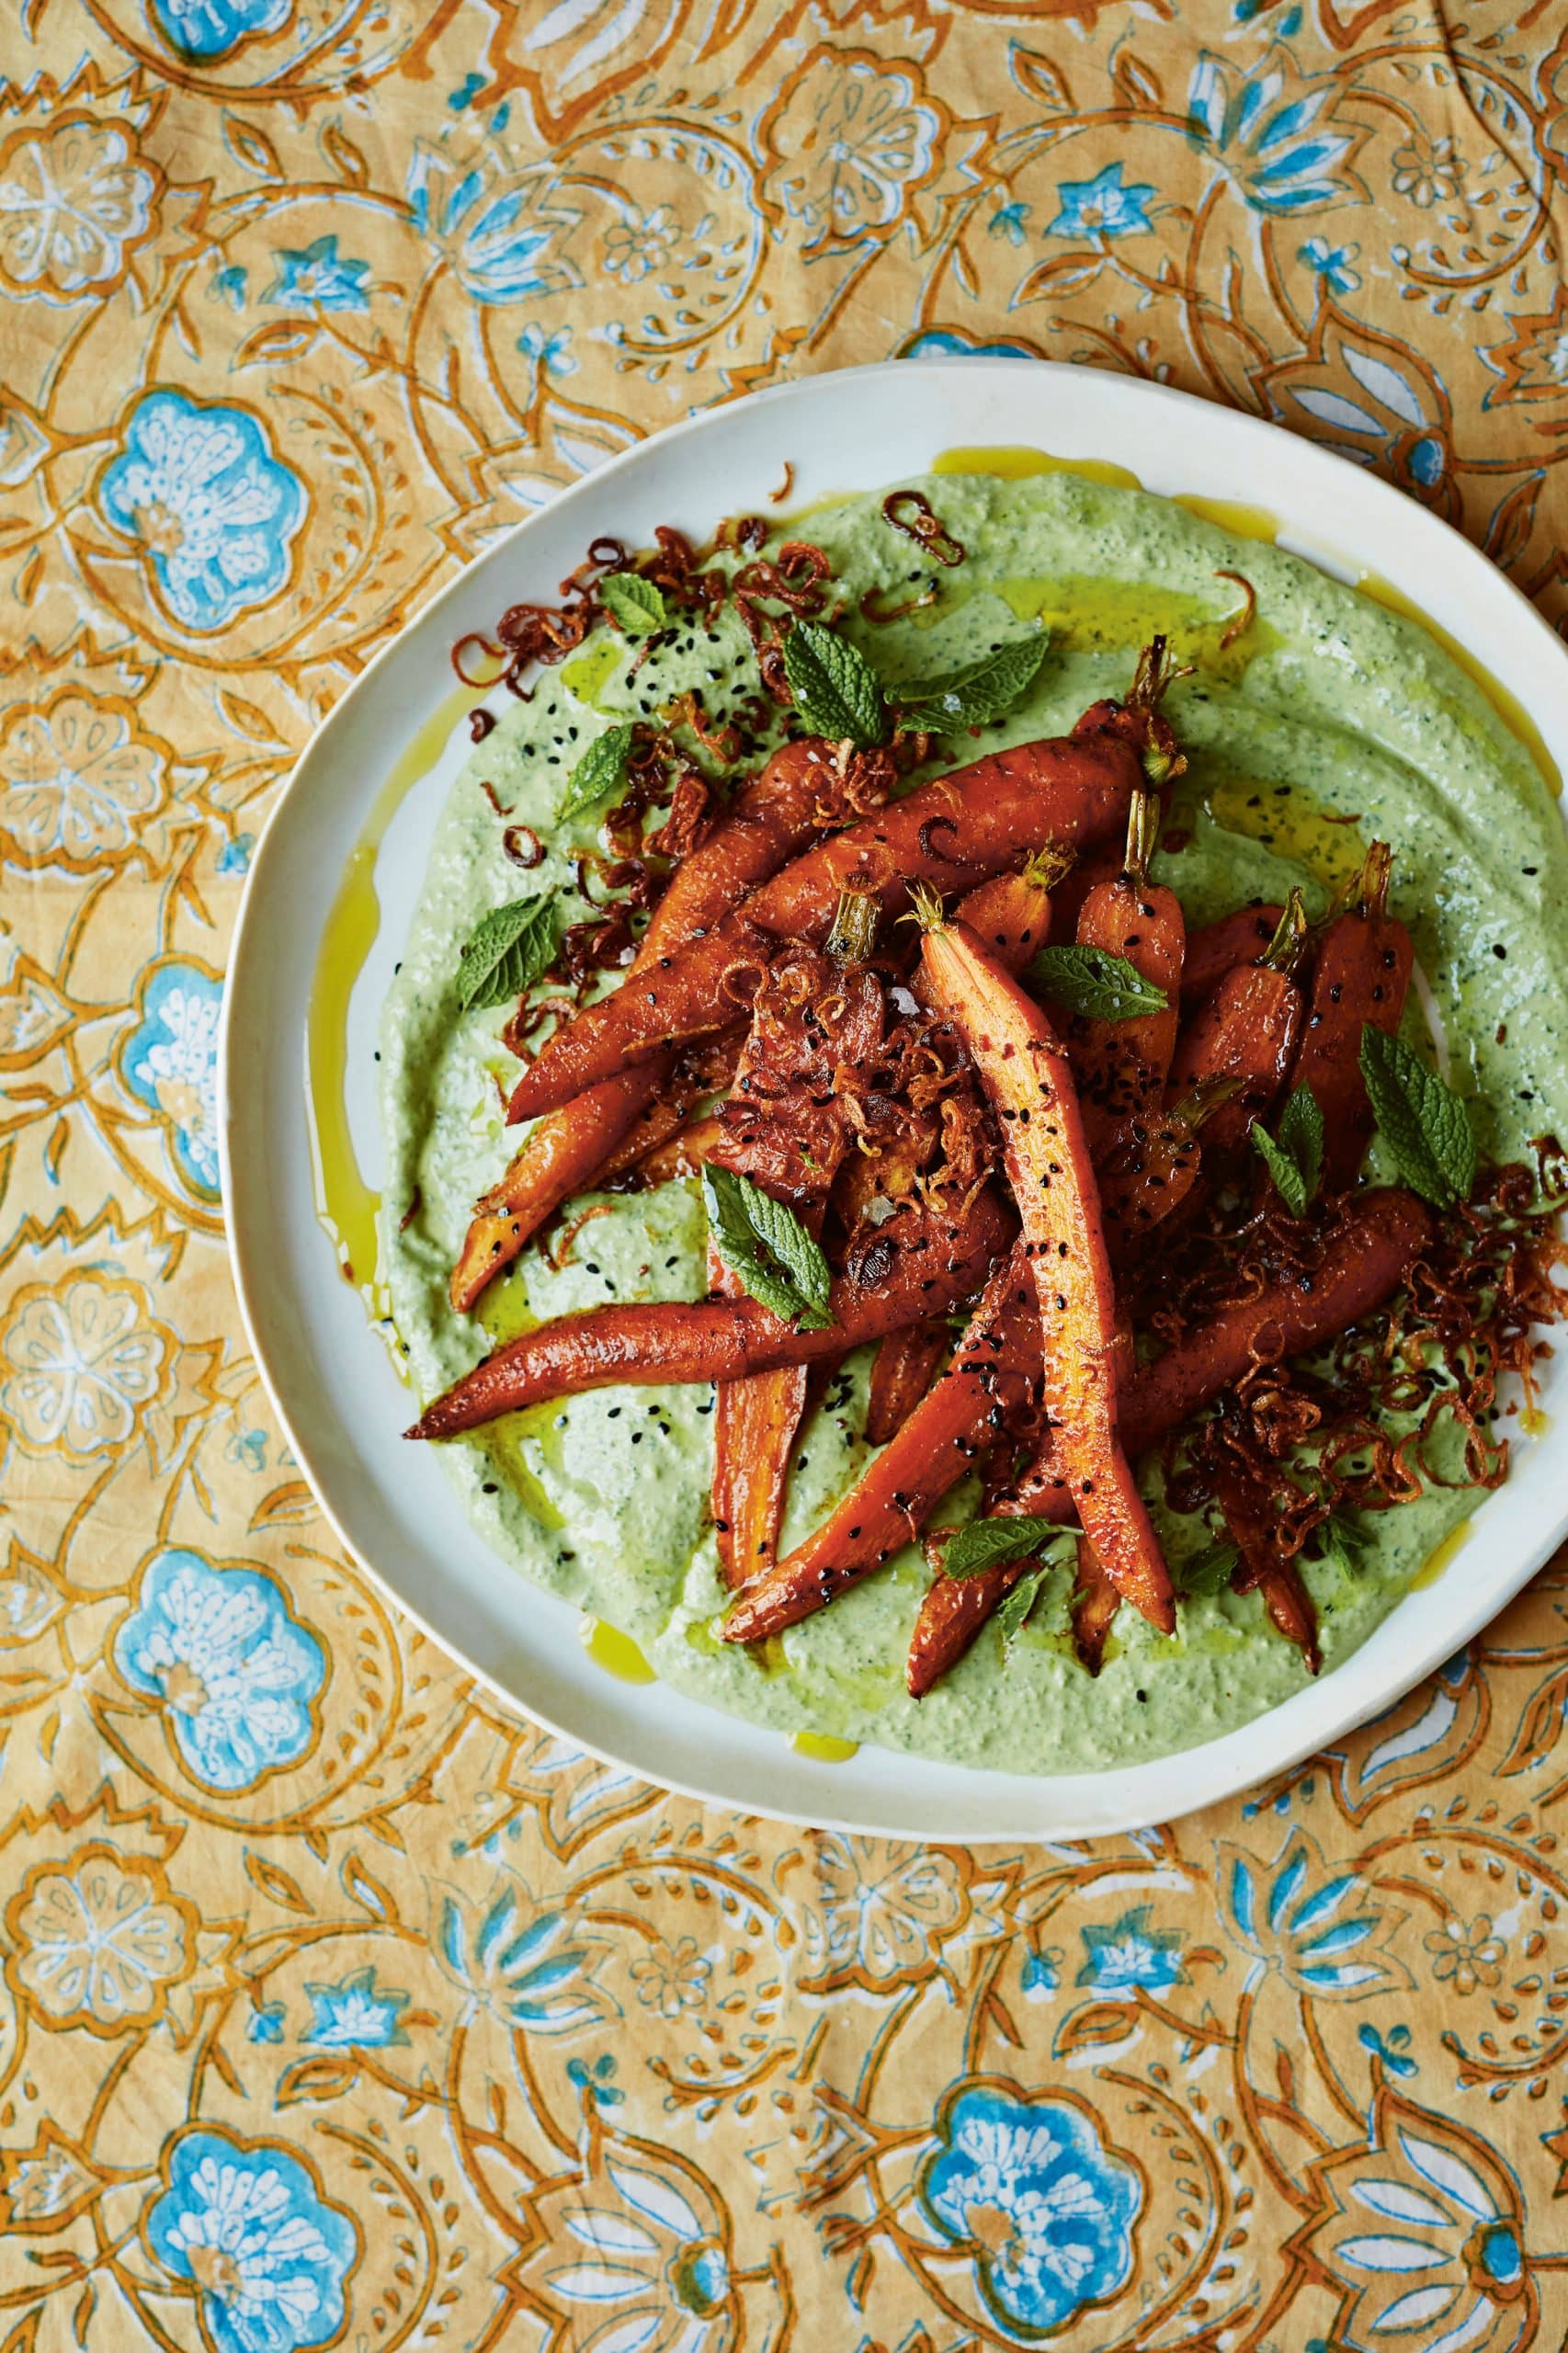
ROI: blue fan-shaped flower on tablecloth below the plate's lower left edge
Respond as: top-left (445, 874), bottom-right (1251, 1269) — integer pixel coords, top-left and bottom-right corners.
top-left (431, 1880), bottom-right (621, 2035)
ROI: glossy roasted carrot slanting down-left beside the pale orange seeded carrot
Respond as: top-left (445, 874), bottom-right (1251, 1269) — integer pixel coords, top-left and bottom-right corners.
top-left (722, 1245), bottom-right (1040, 1643)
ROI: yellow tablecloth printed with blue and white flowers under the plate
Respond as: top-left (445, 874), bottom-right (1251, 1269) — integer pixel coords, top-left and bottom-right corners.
top-left (0, 0), bottom-right (1568, 2353)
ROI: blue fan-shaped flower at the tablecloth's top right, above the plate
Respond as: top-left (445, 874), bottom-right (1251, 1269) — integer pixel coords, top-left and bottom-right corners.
top-left (1187, 42), bottom-right (1366, 214)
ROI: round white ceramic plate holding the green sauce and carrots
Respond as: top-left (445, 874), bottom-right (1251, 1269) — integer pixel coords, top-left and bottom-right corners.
top-left (219, 358), bottom-right (1568, 1842)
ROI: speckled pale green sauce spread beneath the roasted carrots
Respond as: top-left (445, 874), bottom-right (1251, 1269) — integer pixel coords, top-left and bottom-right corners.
top-left (384, 473), bottom-right (1568, 1774)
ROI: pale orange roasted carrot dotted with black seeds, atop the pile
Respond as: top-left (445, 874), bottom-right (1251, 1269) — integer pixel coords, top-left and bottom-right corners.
top-left (921, 911), bottom-right (1175, 1633)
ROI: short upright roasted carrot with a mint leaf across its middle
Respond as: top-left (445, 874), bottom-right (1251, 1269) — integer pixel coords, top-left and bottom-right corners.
top-left (1066, 793), bottom-right (1187, 1155)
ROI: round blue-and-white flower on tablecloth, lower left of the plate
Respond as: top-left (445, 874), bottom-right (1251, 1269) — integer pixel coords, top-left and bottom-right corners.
top-left (113, 1551), bottom-right (327, 1790)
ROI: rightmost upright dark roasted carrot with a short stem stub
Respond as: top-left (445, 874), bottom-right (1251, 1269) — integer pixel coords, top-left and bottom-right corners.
top-left (1290, 842), bottom-right (1413, 1193)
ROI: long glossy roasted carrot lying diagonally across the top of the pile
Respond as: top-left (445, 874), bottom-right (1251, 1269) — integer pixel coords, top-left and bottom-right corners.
top-left (511, 734), bottom-right (1142, 1120)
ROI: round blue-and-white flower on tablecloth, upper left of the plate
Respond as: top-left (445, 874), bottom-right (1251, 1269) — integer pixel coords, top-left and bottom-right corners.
top-left (99, 393), bottom-right (306, 631)
